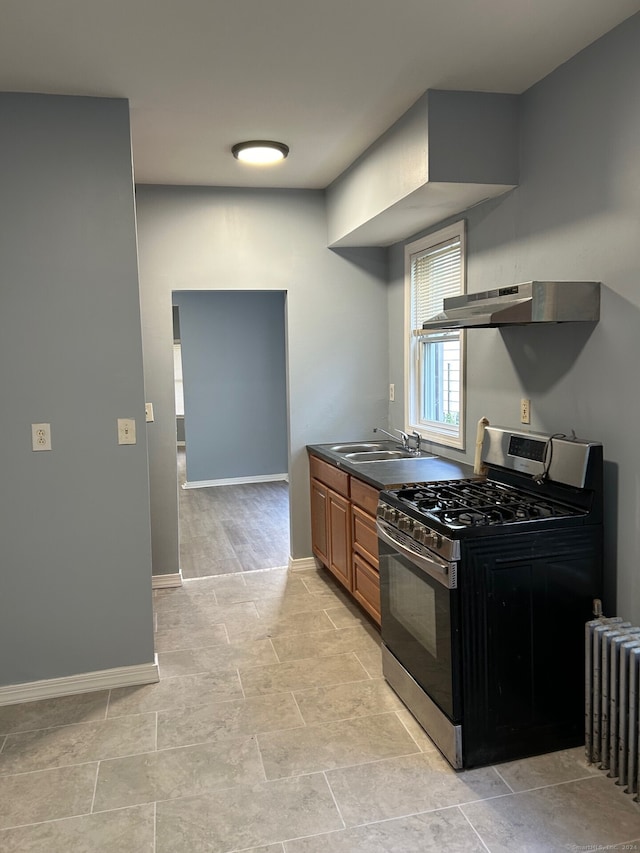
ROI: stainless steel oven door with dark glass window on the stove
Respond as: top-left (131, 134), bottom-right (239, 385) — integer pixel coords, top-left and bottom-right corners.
top-left (378, 519), bottom-right (462, 724)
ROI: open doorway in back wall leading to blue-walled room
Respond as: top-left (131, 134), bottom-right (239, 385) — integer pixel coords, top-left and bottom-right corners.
top-left (172, 290), bottom-right (290, 579)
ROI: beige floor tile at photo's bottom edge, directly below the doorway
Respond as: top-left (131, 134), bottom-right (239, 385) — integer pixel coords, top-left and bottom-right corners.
top-left (156, 773), bottom-right (343, 853)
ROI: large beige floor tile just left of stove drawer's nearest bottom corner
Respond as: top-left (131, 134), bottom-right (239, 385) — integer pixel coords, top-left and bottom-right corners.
top-left (258, 714), bottom-right (417, 779)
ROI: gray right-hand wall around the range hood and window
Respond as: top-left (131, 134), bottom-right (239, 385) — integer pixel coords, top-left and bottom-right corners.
top-left (389, 15), bottom-right (640, 623)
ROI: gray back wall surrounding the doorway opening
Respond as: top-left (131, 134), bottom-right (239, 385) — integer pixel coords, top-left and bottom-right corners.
top-left (137, 186), bottom-right (388, 574)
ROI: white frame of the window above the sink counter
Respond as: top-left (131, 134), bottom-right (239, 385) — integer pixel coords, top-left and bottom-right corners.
top-left (404, 220), bottom-right (467, 450)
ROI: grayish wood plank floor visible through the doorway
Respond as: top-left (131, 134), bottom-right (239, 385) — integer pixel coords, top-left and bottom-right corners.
top-left (177, 448), bottom-right (290, 578)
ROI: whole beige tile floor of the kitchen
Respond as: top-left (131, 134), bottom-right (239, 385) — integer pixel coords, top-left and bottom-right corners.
top-left (0, 569), bottom-right (640, 853)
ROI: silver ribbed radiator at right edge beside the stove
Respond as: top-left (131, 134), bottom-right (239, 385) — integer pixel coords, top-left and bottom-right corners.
top-left (585, 616), bottom-right (640, 801)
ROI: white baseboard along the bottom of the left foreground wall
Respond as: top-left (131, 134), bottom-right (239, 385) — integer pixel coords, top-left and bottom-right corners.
top-left (0, 656), bottom-right (160, 705)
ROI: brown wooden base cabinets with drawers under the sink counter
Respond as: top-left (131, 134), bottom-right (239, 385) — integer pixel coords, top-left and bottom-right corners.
top-left (309, 455), bottom-right (380, 625)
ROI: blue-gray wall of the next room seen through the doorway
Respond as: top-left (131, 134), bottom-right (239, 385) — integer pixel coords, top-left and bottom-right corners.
top-left (173, 290), bottom-right (288, 482)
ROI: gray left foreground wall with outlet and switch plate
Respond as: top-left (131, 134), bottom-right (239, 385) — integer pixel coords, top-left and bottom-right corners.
top-left (0, 94), bottom-right (153, 685)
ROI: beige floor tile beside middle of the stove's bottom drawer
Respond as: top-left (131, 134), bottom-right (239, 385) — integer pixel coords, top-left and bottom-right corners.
top-left (294, 678), bottom-right (404, 725)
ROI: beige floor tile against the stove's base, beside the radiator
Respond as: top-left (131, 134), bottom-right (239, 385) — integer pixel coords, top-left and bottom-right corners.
top-left (496, 747), bottom-right (601, 791)
